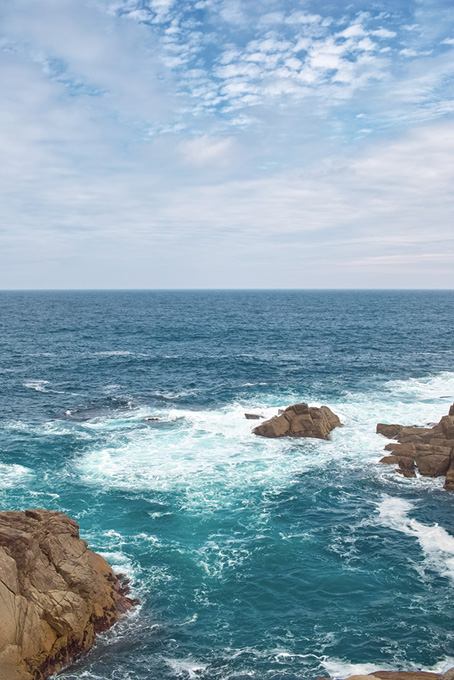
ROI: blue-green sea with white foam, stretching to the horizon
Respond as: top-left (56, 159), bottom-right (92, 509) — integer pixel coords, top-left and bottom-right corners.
top-left (0, 291), bottom-right (454, 680)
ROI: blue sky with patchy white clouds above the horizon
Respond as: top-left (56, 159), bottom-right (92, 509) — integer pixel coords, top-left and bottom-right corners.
top-left (0, 0), bottom-right (454, 289)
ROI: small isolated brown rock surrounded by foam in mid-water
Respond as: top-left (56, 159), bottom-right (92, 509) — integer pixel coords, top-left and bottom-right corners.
top-left (252, 404), bottom-right (342, 439)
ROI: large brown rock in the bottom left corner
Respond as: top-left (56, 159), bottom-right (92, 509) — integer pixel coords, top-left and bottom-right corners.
top-left (0, 510), bottom-right (134, 680)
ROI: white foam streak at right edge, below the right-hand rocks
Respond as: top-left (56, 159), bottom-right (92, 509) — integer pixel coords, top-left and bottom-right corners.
top-left (378, 496), bottom-right (454, 581)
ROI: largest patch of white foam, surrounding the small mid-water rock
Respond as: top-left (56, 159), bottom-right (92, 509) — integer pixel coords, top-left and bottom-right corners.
top-left (75, 373), bottom-right (454, 509)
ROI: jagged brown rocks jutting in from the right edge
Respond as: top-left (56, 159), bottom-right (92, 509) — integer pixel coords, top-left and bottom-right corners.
top-left (377, 404), bottom-right (454, 491)
